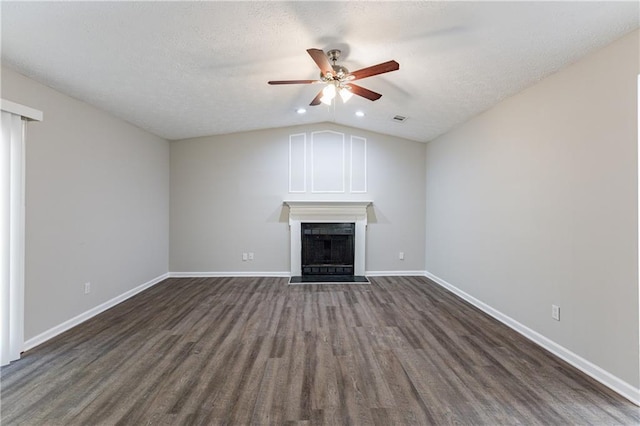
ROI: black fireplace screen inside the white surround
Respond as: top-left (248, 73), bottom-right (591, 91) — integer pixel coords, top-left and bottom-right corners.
top-left (302, 223), bottom-right (355, 275)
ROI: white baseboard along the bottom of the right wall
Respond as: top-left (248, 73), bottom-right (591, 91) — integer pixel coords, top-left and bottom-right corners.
top-left (425, 271), bottom-right (640, 405)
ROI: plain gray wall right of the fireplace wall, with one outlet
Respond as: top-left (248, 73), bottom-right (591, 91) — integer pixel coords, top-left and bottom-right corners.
top-left (426, 31), bottom-right (640, 388)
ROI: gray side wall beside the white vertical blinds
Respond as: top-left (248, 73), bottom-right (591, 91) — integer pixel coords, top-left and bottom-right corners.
top-left (2, 68), bottom-right (169, 340)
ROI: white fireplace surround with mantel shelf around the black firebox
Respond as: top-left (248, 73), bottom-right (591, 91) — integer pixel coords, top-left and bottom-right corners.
top-left (284, 201), bottom-right (373, 277)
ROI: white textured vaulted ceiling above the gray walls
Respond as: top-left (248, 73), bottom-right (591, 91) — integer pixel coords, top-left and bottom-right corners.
top-left (1, 1), bottom-right (640, 142)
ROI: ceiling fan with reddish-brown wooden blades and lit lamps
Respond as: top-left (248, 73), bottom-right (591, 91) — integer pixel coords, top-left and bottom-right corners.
top-left (269, 49), bottom-right (400, 105)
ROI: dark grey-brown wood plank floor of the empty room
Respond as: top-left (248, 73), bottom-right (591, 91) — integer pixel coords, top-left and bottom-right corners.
top-left (1, 277), bottom-right (640, 425)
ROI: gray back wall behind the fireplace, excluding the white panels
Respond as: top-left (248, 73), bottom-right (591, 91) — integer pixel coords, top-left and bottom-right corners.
top-left (170, 123), bottom-right (425, 273)
